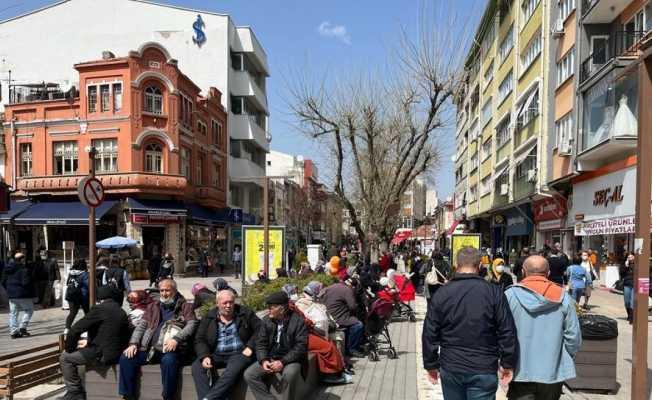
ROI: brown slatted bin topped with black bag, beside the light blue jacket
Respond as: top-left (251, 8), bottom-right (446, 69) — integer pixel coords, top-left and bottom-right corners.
top-left (566, 314), bottom-right (618, 392)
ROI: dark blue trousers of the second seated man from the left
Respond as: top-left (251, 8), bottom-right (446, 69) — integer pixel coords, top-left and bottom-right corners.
top-left (118, 351), bottom-right (179, 400)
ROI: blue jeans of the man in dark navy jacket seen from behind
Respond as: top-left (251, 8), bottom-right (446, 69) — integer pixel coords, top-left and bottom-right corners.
top-left (439, 368), bottom-right (498, 400)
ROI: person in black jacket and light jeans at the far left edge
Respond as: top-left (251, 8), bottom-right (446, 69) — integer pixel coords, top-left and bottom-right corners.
top-left (2, 252), bottom-right (34, 339)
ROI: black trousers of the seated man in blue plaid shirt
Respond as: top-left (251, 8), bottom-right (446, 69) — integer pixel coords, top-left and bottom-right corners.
top-left (192, 353), bottom-right (254, 400)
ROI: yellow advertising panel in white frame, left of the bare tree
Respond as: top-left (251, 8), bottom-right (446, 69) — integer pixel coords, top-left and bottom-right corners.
top-left (242, 225), bottom-right (285, 280)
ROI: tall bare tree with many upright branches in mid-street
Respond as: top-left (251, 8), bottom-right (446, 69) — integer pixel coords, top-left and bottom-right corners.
top-left (289, 6), bottom-right (472, 260)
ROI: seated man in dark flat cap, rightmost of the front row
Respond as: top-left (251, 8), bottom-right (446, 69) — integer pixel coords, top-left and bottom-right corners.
top-left (244, 291), bottom-right (308, 400)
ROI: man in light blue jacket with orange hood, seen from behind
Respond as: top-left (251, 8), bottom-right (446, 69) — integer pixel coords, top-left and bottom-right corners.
top-left (505, 256), bottom-right (582, 400)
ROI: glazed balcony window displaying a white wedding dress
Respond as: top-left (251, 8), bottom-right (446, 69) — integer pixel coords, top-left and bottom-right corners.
top-left (577, 69), bottom-right (639, 171)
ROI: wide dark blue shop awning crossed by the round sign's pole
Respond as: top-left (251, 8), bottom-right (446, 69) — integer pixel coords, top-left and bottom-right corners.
top-left (13, 200), bottom-right (117, 225)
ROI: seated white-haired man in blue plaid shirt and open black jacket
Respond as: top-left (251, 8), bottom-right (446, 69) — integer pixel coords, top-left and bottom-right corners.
top-left (192, 290), bottom-right (260, 400)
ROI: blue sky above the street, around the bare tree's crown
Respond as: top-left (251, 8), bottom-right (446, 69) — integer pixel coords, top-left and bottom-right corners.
top-left (0, 0), bottom-right (485, 198)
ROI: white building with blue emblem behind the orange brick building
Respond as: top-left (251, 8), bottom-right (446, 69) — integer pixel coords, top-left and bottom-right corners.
top-left (0, 0), bottom-right (271, 212)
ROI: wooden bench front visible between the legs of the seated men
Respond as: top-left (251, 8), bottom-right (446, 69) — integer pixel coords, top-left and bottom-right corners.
top-left (85, 354), bottom-right (319, 400)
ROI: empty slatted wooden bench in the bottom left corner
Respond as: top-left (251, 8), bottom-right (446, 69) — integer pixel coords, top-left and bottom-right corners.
top-left (0, 336), bottom-right (64, 400)
